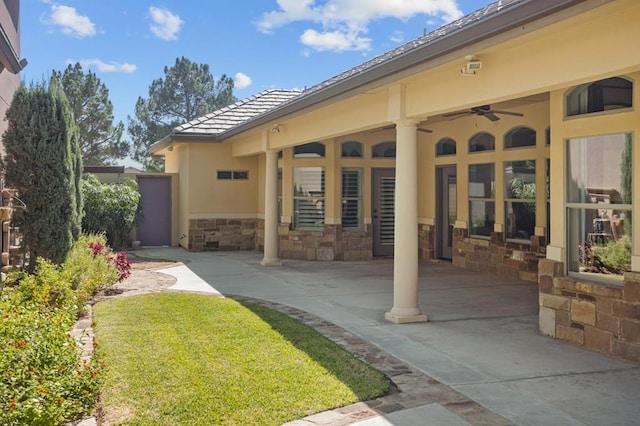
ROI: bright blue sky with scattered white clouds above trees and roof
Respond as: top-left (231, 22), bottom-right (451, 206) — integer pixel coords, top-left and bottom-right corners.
top-left (20, 0), bottom-right (491, 162)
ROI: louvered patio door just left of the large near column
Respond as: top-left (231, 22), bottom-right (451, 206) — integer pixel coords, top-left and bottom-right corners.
top-left (371, 169), bottom-right (396, 256)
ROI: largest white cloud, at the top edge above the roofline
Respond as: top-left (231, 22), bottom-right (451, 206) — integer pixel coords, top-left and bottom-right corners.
top-left (258, 0), bottom-right (462, 51)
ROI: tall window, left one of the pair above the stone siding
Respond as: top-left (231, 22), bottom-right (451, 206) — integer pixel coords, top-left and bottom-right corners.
top-left (469, 163), bottom-right (496, 237)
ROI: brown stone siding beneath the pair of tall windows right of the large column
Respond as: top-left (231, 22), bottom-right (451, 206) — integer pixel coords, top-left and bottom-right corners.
top-left (452, 228), bottom-right (546, 282)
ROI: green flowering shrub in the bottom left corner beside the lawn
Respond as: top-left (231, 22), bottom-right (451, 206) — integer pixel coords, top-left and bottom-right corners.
top-left (0, 298), bottom-right (103, 425)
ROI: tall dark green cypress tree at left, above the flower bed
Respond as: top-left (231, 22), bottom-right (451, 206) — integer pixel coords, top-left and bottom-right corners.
top-left (3, 79), bottom-right (82, 267)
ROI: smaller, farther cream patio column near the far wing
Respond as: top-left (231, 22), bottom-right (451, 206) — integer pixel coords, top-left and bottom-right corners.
top-left (260, 150), bottom-right (282, 266)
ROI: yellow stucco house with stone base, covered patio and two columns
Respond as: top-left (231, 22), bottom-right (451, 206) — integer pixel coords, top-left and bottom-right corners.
top-left (151, 0), bottom-right (640, 360)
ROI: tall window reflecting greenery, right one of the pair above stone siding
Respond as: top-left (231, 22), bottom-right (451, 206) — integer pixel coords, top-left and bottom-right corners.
top-left (504, 160), bottom-right (536, 242)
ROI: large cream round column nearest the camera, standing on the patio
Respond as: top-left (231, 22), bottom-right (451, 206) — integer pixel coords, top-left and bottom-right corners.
top-left (385, 120), bottom-right (427, 324)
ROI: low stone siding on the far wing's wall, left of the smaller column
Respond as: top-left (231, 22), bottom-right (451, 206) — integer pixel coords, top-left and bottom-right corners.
top-left (189, 219), bottom-right (258, 251)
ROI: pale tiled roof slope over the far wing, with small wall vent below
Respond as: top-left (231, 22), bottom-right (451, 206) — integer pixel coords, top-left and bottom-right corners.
top-left (172, 89), bottom-right (302, 135)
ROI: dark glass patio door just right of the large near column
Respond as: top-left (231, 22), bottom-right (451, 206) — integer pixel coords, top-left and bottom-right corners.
top-left (436, 165), bottom-right (458, 259)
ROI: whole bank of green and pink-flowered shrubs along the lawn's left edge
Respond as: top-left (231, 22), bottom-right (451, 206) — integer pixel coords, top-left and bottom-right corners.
top-left (0, 235), bottom-right (130, 425)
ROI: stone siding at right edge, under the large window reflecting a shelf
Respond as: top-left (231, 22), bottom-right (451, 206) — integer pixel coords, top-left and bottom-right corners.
top-left (538, 259), bottom-right (640, 362)
